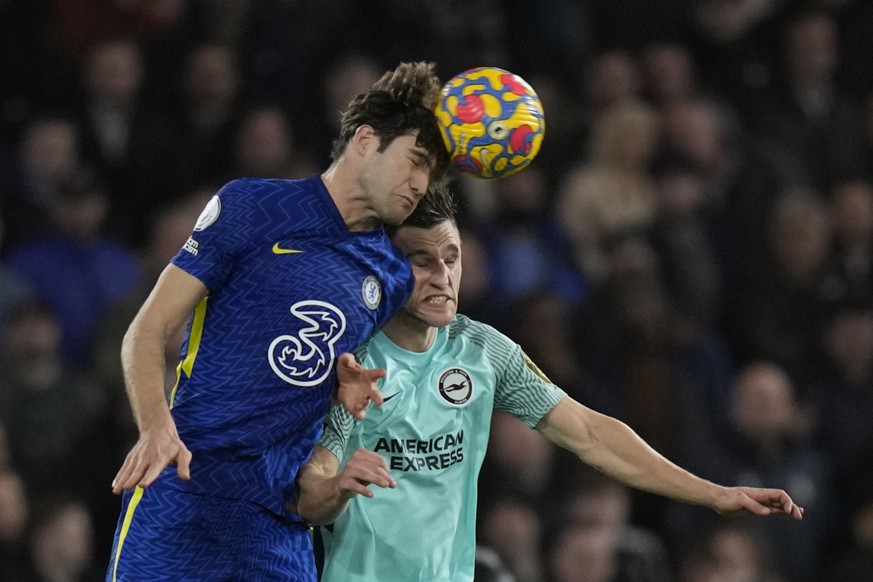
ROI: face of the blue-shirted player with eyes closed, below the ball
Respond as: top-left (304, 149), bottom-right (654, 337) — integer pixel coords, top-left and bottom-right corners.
top-left (361, 135), bottom-right (431, 224)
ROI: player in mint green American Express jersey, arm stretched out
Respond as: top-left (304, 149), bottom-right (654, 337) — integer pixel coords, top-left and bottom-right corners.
top-left (298, 187), bottom-right (803, 582)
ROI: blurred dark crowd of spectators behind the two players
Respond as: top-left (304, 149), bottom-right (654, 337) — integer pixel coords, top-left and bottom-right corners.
top-left (0, 0), bottom-right (873, 582)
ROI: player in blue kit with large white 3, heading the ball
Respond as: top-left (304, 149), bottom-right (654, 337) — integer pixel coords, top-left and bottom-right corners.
top-left (106, 62), bottom-right (448, 582)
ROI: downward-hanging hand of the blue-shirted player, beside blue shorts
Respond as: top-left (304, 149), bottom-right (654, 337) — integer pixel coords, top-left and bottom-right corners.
top-left (112, 424), bottom-right (191, 495)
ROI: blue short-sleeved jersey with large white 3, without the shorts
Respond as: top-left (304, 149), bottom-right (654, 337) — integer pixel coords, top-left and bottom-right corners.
top-left (170, 176), bottom-right (412, 513)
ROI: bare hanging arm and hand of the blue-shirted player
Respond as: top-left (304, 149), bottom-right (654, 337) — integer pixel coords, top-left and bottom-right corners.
top-left (112, 264), bottom-right (207, 494)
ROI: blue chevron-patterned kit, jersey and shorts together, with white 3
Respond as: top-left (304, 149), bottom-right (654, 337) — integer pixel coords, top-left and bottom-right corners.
top-left (106, 176), bottom-right (412, 582)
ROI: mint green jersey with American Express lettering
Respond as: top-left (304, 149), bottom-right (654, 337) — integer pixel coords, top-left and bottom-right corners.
top-left (319, 315), bottom-right (566, 582)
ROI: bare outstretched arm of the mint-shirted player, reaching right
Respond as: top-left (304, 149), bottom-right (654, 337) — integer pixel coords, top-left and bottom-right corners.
top-left (537, 398), bottom-right (803, 519)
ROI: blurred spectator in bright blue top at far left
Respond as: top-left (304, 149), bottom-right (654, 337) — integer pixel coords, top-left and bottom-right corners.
top-left (7, 173), bottom-right (142, 370)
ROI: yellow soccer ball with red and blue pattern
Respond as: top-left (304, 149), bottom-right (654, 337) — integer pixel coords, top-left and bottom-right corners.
top-left (435, 67), bottom-right (546, 178)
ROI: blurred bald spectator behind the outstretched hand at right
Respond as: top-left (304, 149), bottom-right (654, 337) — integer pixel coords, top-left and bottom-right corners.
top-left (665, 360), bottom-right (839, 582)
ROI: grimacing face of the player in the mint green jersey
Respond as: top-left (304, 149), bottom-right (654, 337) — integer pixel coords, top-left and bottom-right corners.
top-left (394, 220), bottom-right (461, 327)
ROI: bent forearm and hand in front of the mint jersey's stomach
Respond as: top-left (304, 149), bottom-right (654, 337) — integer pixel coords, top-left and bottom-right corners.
top-left (297, 445), bottom-right (396, 525)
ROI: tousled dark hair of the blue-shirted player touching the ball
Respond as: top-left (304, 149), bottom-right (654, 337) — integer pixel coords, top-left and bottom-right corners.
top-left (330, 61), bottom-right (449, 182)
